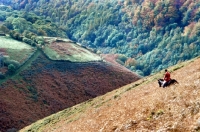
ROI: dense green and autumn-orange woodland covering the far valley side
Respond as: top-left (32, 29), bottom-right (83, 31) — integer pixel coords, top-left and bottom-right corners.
top-left (0, 0), bottom-right (200, 76)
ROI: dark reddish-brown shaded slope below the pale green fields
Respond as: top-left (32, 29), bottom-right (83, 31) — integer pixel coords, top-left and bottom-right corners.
top-left (0, 37), bottom-right (140, 132)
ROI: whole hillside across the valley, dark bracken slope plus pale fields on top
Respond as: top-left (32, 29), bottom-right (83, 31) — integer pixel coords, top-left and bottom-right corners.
top-left (0, 37), bottom-right (140, 132)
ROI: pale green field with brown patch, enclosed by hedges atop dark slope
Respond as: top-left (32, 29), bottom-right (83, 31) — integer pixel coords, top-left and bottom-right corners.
top-left (44, 39), bottom-right (101, 62)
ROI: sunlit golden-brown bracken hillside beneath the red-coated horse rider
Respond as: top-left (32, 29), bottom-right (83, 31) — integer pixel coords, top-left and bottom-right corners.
top-left (20, 58), bottom-right (200, 132)
